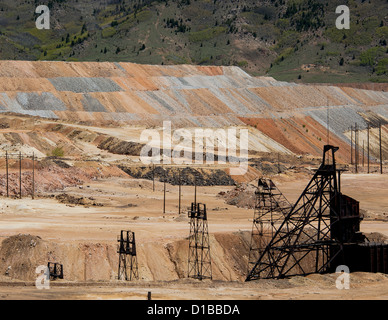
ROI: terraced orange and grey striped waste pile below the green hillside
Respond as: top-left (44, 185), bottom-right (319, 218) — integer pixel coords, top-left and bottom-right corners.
top-left (0, 61), bottom-right (388, 159)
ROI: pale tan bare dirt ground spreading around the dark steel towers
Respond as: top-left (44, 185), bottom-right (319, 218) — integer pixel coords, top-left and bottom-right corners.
top-left (0, 174), bottom-right (388, 300)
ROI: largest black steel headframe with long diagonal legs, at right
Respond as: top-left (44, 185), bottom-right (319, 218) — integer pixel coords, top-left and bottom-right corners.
top-left (246, 145), bottom-right (359, 281)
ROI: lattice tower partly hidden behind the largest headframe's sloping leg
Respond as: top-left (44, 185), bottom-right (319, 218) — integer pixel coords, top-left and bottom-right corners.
top-left (248, 178), bottom-right (291, 272)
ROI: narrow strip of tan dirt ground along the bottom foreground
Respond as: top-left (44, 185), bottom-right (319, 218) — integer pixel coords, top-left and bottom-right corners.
top-left (0, 273), bottom-right (388, 300)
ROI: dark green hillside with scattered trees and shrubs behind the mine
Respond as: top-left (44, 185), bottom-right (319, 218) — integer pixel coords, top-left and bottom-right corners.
top-left (0, 0), bottom-right (388, 82)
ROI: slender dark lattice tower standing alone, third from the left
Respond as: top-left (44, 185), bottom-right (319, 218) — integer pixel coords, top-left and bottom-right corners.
top-left (188, 203), bottom-right (212, 280)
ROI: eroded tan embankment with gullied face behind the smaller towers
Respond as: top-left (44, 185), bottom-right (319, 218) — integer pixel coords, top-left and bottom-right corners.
top-left (0, 232), bottom-right (250, 281)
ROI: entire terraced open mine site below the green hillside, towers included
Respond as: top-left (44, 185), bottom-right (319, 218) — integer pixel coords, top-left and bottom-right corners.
top-left (0, 61), bottom-right (388, 300)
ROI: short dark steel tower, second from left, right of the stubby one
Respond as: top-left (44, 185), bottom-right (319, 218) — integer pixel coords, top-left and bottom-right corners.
top-left (117, 230), bottom-right (139, 281)
